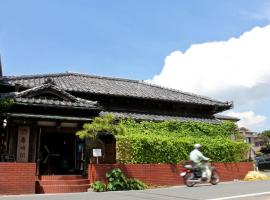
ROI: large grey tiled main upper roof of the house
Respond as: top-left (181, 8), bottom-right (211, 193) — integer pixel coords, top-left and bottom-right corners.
top-left (4, 73), bottom-right (232, 110)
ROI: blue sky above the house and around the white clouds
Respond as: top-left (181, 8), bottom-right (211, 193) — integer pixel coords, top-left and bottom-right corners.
top-left (0, 0), bottom-right (270, 131)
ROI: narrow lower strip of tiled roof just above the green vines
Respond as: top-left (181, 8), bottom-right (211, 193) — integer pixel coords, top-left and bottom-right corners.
top-left (99, 111), bottom-right (221, 124)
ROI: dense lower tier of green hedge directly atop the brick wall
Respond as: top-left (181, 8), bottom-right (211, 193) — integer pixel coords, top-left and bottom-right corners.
top-left (117, 134), bottom-right (248, 163)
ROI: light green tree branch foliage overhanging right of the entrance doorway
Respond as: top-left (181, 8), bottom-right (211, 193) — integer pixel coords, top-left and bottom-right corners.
top-left (76, 114), bottom-right (125, 140)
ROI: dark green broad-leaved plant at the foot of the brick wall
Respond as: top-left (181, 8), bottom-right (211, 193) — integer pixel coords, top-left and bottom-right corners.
top-left (106, 168), bottom-right (146, 191)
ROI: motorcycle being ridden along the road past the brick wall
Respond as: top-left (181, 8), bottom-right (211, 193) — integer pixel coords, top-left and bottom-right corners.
top-left (180, 161), bottom-right (219, 187)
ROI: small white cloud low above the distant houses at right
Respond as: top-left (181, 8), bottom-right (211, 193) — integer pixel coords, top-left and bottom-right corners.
top-left (227, 111), bottom-right (266, 129)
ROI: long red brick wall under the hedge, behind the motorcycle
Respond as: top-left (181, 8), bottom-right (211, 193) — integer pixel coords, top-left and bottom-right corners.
top-left (88, 162), bottom-right (253, 185)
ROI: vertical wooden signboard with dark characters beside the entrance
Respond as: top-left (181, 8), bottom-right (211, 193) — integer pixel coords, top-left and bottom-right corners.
top-left (17, 126), bottom-right (30, 162)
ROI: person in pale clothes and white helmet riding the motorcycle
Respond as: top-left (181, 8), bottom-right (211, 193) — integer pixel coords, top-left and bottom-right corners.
top-left (189, 144), bottom-right (211, 180)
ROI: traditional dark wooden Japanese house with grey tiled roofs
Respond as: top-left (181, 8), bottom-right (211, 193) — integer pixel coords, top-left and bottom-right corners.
top-left (0, 70), bottom-right (232, 194)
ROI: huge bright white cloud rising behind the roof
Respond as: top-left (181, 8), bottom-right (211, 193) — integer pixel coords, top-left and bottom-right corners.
top-left (150, 25), bottom-right (270, 104)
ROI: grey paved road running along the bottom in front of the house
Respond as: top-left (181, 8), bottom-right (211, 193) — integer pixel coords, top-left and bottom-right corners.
top-left (0, 181), bottom-right (270, 200)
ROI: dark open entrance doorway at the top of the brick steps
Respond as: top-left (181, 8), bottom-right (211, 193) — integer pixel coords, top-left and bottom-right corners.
top-left (39, 133), bottom-right (76, 175)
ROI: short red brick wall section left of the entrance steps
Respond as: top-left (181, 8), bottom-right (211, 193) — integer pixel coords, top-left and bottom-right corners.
top-left (0, 162), bottom-right (36, 194)
